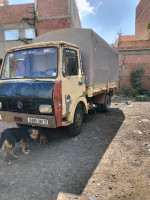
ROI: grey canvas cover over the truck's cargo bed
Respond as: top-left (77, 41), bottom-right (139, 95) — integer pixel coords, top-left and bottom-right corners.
top-left (33, 28), bottom-right (119, 87)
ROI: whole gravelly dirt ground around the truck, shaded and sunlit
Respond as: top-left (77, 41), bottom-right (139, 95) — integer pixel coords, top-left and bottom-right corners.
top-left (0, 97), bottom-right (150, 200)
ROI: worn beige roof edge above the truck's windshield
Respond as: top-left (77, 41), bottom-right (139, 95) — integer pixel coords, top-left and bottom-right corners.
top-left (5, 41), bottom-right (80, 53)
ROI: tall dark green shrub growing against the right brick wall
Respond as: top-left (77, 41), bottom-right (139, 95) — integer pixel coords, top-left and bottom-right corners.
top-left (130, 66), bottom-right (145, 93)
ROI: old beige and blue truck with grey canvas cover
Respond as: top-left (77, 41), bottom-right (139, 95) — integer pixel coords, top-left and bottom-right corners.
top-left (0, 28), bottom-right (119, 136)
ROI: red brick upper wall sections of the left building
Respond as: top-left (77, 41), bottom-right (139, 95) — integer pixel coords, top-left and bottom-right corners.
top-left (0, 0), bottom-right (79, 36)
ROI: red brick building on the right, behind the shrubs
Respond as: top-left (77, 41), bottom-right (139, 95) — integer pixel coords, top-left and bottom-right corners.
top-left (114, 0), bottom-right (150, 90)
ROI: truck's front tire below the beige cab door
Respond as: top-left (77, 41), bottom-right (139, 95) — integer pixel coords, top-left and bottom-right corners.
top-left (68, 106), bottom-right (83, 137)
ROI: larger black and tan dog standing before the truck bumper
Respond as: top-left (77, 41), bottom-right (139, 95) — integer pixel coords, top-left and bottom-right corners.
top-left (0, 128), bottom-right (39, 160)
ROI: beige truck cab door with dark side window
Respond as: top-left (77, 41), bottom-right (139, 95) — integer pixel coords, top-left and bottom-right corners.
top-left (62, 48), bottom-right (85, 116)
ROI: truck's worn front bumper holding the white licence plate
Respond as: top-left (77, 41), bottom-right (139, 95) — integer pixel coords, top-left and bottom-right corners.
top-left (0, 111), bottom-right (57, 128)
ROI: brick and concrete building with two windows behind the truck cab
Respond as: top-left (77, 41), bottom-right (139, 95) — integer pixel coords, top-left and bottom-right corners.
top-left (0, 0), bottom-right (81, 58)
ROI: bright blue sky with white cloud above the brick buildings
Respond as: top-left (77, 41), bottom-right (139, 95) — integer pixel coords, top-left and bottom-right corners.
top-left (9, 0), bottom-right (140, 44)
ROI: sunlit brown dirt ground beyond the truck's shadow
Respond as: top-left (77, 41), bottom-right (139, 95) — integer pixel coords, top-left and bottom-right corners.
top-left (58, 97), bottom-right (150, 200)
